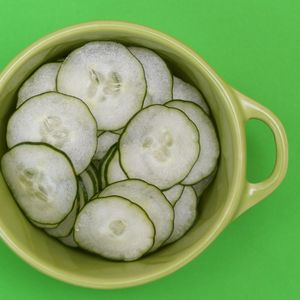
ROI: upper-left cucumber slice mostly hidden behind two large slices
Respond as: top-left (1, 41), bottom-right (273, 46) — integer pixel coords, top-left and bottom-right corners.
top-left (17, 62), bottom-right (61, 108)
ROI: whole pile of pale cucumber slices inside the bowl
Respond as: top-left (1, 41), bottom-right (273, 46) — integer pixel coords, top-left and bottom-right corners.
top-left (1, 41), bottom-right (220, 261)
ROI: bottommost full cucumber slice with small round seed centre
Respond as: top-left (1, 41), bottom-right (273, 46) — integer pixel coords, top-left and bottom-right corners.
top-left (74, 196), bottom-right (155, 261)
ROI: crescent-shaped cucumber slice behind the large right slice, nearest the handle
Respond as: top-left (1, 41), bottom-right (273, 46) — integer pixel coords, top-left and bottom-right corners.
top-left (166, 100), bottom-right (220, 185)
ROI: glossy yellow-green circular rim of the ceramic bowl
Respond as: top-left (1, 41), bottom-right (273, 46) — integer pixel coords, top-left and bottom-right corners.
top-left (0, 21), bottom-right (246, 289)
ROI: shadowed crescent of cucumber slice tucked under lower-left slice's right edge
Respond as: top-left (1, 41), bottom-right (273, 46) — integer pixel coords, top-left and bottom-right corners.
top-left (45, 195), bottom-right (79, 237)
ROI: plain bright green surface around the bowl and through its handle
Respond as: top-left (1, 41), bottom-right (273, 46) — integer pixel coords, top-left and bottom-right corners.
top-left (0, 0), bottom-right (300, 300)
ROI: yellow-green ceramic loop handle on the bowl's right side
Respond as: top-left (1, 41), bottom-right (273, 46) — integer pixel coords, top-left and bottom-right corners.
top-left (233, 90), bottom-right (288, 218)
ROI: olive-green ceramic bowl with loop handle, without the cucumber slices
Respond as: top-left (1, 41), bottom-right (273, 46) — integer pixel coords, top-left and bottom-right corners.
top-left (0, 21), bottom-right (288, 289)
